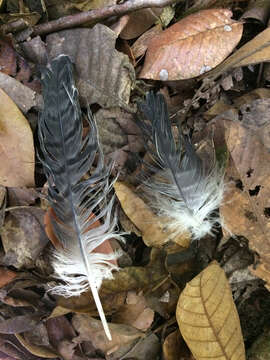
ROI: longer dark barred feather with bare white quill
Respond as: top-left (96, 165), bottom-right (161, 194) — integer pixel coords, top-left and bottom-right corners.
top-left (39, 55), bottom-right (120, 339)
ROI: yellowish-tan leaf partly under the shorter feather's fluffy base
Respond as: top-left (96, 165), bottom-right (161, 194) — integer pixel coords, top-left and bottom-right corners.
top-left (114, 181), bottom-right (190, 247)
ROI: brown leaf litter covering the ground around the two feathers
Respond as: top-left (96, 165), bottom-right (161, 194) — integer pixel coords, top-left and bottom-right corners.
top-left (0, 0), bottom-right (270, 360)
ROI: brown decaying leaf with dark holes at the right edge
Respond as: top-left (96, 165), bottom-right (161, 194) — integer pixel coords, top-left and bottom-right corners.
top-left (221, 122), bottom-right (270, 287)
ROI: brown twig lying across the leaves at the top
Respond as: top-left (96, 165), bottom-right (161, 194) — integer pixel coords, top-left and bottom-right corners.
top-left (33, 0), bottom-right (179, 36)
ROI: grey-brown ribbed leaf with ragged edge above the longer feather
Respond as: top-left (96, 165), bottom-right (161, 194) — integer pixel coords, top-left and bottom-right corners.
top-left (47, 24), bottom-right (135, 111)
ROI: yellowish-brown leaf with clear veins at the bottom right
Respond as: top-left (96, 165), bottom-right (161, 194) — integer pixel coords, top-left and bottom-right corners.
top-left (176, 261), bottom-right (245, 360)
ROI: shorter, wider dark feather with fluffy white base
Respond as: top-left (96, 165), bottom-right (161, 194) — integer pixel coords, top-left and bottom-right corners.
top-left (137, 92), bottom-right (224, 240)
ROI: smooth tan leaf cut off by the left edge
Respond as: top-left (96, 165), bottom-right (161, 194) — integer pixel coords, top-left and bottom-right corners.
top-left (0, 89), bottom-right (35, 186)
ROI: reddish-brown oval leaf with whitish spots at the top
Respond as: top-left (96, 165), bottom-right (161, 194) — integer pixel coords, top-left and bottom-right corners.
top-left (140, 9), bottom-right (243, 81)
